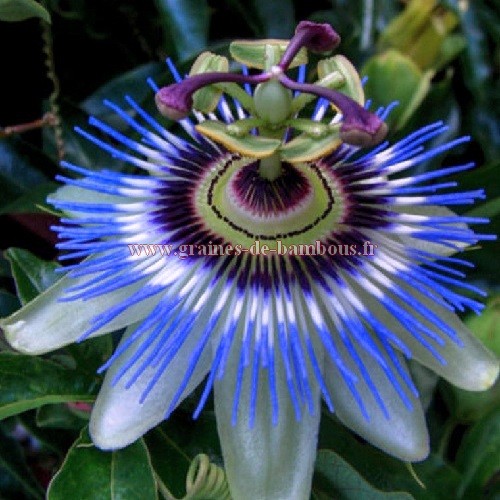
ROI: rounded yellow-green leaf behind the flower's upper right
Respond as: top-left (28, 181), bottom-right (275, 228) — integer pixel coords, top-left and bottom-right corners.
top-left (362, 50), bottom-right (433, 129)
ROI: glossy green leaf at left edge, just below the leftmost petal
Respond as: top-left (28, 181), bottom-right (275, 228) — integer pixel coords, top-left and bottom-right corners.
top-left (0, 352), bottom-right (98, 419)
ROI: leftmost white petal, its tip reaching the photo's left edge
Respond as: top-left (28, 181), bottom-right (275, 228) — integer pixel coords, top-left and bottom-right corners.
top-left (0, 276), bottom-right (159, 354)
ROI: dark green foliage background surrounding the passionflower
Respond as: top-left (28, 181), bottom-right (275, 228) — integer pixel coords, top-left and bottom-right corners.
top-left (0, 0), bottom-right (500, 500)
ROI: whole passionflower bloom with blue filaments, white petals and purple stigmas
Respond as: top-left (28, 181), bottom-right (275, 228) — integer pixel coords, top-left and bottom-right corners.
top-left (2, 22), bottom-right (498, 499)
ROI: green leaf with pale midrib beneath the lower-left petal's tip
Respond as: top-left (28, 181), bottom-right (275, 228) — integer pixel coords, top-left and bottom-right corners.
top-left (47, 428), bottom-right (157, 500)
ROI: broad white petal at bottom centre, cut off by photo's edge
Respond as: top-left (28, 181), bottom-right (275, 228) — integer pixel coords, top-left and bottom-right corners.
top-left (215, 328), bottom-right (320, 500)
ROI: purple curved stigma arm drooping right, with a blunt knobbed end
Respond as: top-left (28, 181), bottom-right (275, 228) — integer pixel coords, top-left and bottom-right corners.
top-left (279, 75), bottom-right (387, 147)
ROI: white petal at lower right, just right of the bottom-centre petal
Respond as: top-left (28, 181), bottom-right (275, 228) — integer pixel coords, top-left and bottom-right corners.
top-left (325, 343), bottom-right (429, 462)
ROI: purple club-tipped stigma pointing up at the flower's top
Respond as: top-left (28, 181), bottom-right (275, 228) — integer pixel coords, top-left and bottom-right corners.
top-left (279, 21), bottom-right (340, 70)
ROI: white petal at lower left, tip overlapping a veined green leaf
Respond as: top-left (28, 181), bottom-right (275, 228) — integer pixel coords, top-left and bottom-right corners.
top-left (89, 325), bottom-right (211, 450)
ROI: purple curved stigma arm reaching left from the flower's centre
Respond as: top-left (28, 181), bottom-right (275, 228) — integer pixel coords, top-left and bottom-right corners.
top-left (155, 72), bottom-right (271, 121)
